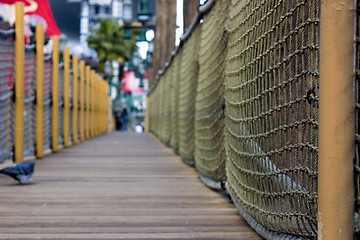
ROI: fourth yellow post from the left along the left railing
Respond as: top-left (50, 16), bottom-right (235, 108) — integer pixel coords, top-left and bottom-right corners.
top-left (63, 47), bottom-right (70, 147)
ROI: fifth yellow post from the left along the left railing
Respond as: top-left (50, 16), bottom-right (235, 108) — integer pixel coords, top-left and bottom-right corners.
top-left (72, 55), bottom-right (78, 144)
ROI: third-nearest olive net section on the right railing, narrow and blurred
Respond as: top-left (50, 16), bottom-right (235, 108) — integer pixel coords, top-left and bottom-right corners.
top-left (178, 25), bottom-right (201, 165)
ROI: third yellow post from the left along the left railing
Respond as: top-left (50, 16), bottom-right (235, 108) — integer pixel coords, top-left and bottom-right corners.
top-left (51, 36), bottom-right (59, 152)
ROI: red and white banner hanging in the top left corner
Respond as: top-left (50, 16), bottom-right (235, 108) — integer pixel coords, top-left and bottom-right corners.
top-left (0, 0), bottom-right (61, 36)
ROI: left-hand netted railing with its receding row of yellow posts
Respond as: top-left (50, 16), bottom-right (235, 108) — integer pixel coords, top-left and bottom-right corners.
top-left (0, 3), bottom-right (111, 168)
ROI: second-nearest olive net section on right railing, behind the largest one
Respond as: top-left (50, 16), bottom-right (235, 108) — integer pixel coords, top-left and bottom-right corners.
top-left (195, 1), bottom-right (228, 181)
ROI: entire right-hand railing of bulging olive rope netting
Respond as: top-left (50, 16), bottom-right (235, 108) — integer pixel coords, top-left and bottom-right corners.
top-left (148, 0), bottom-right (360, 239)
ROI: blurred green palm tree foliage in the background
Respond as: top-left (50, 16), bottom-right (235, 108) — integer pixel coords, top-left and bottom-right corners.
top-left (87, 19), bottom-right (137, 72)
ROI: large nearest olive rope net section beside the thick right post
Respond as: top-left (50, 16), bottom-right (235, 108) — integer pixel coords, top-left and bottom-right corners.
top-left (225, 0), bottom-right (319, 237)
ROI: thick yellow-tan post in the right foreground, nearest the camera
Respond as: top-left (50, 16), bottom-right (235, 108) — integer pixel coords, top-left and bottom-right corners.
top-left (318, 0), bottom-right (356, 240)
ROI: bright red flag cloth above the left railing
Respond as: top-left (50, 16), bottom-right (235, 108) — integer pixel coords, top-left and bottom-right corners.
top-left (0, 0), bottom-right (61, 36)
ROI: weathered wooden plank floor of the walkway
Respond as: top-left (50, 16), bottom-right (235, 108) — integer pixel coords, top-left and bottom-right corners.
top-left (0, 132), bottom-right (261, 240)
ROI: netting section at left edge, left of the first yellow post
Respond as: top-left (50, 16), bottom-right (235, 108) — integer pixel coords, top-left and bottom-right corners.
top-left (0, 30), bottom-right (15, 163)
